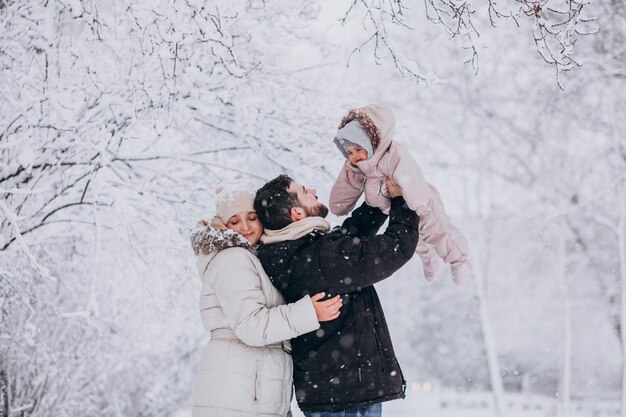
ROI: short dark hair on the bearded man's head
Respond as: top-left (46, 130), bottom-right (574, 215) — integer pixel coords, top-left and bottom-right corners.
top-left (254, 174), bottom-right (298, 230)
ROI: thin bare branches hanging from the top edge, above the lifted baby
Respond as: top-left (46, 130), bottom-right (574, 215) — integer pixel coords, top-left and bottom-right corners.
top-left (334, 0), bottom-right (598, 85)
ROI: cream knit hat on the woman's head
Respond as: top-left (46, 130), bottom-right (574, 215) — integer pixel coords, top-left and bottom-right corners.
top-left (215, 180), bottom-right (257, 224)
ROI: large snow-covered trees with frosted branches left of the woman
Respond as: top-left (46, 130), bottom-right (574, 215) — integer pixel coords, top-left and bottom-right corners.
top-left (0, 1), bottom-right (336, 416)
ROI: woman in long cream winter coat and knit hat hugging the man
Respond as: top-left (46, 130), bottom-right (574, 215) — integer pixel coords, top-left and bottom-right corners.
top-left (192, 183), bottom-right (341, 417)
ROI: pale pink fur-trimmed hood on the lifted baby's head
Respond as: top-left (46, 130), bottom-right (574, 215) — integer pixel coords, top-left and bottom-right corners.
top-left (339, 104), bottom-right (396, 157)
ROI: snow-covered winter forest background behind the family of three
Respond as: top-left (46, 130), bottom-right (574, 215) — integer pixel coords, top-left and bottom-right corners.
top-left (0, 0), bottom-right (626, 417)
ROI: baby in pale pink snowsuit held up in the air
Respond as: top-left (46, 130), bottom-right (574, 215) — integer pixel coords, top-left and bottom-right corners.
top-left (330, 105), bottom-right (472, 284)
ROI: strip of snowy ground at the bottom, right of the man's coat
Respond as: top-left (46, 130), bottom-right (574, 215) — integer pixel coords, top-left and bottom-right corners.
top-left (291, 390), bottom-right (619, 417)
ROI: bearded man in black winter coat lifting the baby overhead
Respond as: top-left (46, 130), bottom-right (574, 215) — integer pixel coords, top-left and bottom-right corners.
top-left (254, 175), bottom-right (419, 417)
